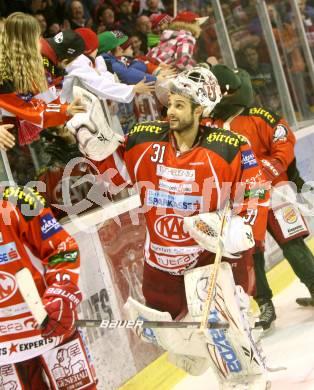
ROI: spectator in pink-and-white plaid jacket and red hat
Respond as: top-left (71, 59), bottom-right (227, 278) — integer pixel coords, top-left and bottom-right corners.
top-left (147, 11), bottom-right (206, 70)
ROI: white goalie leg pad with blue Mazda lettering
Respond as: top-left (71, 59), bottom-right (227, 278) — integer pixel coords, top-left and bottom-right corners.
top-left (184, 263), bottom-right (265, 380)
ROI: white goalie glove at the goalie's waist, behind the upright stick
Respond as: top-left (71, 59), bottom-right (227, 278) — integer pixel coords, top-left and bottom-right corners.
top-left (184, 211), bottom-right (255, 258)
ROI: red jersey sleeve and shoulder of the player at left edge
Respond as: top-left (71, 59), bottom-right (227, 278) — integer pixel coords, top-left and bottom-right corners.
top-left (5, 187), bottom-right (80, 286)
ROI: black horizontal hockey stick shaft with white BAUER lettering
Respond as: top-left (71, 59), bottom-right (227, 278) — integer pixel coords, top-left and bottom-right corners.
top-left (75, 320), bottom-right (229, 329)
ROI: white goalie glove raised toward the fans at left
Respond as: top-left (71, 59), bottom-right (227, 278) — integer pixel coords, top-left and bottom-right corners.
top-left (66, 87), bottom-right (124, 161)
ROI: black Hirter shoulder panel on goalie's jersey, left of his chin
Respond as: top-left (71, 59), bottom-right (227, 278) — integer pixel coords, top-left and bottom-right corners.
top-left (126, 121), bottom-right (169, 151)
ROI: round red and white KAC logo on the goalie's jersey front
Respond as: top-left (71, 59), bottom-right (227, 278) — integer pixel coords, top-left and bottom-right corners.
top-left (154, 214), bottom-right (191, 242)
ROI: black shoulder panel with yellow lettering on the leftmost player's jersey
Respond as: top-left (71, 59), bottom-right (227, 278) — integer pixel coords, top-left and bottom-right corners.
top-left (0, 186), bottom-right (46, 221)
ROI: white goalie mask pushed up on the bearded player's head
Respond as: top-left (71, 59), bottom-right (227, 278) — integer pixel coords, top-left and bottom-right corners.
top-left (156, 67), bottom-right (222, 116)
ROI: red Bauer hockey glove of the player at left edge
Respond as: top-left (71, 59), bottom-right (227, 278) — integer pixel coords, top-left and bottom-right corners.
top-left (42, 282), bottom-right (82, 337)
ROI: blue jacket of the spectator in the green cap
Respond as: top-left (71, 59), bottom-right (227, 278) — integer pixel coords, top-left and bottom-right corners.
top-left (101, 53), bottom-right (156, 84)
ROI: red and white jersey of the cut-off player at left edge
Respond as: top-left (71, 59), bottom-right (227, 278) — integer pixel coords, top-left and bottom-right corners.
top-left (0, 187), bottom-right (80, 365)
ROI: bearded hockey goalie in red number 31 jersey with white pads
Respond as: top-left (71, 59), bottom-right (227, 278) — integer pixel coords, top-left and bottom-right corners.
top-left (67, 67), bottom-right (269, 390)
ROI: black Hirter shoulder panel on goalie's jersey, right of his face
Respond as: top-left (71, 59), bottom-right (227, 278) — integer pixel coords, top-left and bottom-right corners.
top-left (201, 127), bottom-right (247, 164)
